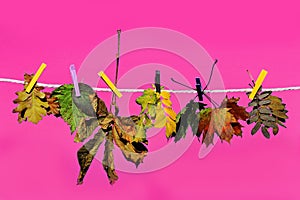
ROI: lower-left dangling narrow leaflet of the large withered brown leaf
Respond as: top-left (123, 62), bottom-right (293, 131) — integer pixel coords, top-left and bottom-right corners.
top-left (77, 129), bottom-right (105, 184)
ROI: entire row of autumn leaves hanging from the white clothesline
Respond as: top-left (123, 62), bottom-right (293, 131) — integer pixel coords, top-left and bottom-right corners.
top-left (13, 74), bottom-right (288, 184)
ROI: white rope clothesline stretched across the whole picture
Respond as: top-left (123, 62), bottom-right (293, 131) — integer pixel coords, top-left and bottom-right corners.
top-left (0, 78), bottom-right (300, 93)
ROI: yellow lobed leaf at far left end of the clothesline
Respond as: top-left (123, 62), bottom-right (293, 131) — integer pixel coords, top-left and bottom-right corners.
top-left (13, 74), bottom-right (49, 124)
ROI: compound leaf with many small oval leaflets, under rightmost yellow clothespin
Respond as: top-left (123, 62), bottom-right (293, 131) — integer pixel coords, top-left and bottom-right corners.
top-left (247, 88), bottom-right (288, 138)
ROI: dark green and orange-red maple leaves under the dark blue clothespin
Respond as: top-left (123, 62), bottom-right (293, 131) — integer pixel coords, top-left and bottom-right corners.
top-left (174, 97), bottom-right (249, 146)
